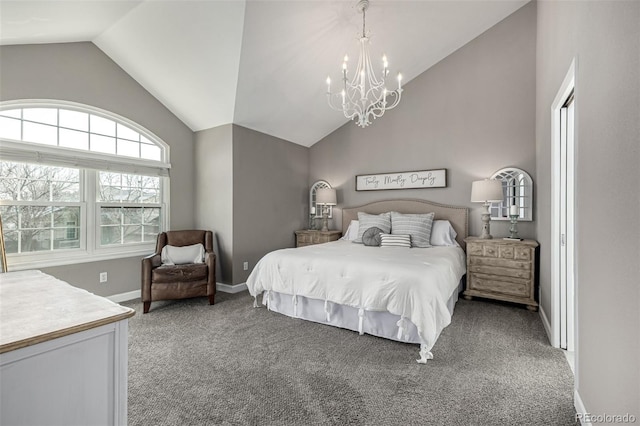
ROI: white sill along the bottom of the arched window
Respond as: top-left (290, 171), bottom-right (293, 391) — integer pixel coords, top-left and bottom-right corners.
top-left (7, 245), bottom-right (155, 271)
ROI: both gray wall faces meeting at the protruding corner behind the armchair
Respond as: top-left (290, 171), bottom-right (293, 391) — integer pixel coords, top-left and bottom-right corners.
top-left (195, 124), bottom-right (309, 284)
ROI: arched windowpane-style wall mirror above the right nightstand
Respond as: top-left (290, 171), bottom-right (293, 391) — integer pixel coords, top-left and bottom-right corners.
top-left (490, 167), bottom-right (533, 221)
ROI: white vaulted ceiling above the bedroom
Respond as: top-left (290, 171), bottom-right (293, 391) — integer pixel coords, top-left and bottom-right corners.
top-left (0, 0), bottom-right (529, 146)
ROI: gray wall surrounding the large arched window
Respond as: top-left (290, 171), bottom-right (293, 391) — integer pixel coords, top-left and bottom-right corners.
top-left (0, 42), bottom-right (195, 296)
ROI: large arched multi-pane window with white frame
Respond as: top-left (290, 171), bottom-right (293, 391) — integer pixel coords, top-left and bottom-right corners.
top-left (0, 101), bottom-right (170, 269)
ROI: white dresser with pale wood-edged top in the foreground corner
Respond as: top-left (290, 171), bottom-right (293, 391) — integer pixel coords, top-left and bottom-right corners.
top-left (0, 271), bottom-right (135, 426)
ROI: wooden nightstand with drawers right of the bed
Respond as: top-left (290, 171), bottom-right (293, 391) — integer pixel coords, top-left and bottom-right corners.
top-left (463, 237), bottom-right (538, 311)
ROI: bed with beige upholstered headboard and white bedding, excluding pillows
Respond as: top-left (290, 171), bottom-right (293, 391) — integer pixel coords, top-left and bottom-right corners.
top-left (247, 199), bottom-right (468, 364)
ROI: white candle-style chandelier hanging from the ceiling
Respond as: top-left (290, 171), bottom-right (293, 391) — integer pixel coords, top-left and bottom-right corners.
top-left (327, 0), bottom-right (402, 128)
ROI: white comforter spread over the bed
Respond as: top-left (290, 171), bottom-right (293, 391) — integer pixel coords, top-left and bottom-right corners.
top-left (247, 241), bottom-right (466, 348)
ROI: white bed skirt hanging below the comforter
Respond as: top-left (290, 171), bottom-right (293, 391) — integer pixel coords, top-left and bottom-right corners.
top-left (262, 280), bottom-right (464, 350)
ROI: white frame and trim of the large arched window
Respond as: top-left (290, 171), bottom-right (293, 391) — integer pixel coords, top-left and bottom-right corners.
top-left (0, 100), bottom-right (171, 271)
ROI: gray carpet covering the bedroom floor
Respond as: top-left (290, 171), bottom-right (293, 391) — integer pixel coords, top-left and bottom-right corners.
top-left (125, 292), bottom-right (575, 425)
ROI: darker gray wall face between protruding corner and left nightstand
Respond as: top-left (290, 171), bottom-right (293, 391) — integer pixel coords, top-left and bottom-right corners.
top-left (233, 125), bottom-right (309, 284)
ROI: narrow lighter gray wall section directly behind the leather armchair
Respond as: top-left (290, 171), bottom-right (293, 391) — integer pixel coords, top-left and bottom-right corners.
top-left (195, 124), bottom-right (234, 283)
